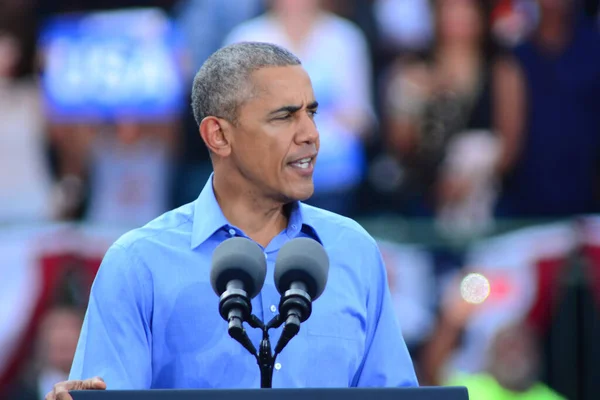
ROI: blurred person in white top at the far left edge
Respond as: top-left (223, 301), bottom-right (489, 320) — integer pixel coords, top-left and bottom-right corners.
top-left (0, 18), bottom-right (53, 223)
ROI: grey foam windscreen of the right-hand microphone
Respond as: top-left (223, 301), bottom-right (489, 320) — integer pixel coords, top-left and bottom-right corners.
top-left (275, 238), bottom-right (329, 301)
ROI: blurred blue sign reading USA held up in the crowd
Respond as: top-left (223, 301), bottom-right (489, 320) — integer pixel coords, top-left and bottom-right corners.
top-left (39, 9), bottom-right (187, 120)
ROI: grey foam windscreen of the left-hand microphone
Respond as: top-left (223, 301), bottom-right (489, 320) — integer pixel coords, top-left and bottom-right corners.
top-left (210, 237), bottom-right (267, 299)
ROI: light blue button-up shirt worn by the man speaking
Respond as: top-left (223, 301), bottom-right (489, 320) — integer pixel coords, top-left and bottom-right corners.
top-left (70, 176), bottom-right (418, 389)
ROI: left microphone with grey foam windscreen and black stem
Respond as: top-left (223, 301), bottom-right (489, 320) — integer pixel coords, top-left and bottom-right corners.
top-left (210, 237), bottom-right (267, 354)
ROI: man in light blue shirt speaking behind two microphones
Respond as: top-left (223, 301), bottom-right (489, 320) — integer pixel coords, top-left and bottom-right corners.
top-left (47, 43), bottom-right (417, 399)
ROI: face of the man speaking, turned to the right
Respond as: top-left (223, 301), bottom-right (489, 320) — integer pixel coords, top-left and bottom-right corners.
top-left (231, 66), bottom-right (319, 202)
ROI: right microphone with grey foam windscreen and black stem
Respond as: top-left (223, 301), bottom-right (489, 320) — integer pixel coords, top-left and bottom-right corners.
top-left (274, 238), bottom-right (329, 354)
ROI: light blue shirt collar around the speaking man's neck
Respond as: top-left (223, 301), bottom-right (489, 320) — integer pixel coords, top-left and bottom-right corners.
top-left (191, 174), bottom-right (323, 249)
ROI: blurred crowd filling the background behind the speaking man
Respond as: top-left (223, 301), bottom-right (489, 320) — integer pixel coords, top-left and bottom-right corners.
top-left (0, 0), bottom-right (600, 400)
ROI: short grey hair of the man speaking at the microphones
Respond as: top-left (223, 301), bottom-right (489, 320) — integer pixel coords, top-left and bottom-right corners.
top-left (192, 42), bottom-right (301, 125)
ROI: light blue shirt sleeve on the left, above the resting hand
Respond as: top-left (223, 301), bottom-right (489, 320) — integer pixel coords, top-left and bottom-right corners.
top-left (69, 244), bottom-right (152, 390)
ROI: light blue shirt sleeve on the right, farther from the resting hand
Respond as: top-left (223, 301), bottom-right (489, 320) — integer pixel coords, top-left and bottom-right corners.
top-left (355, 242), bottom-right (419, 387)
